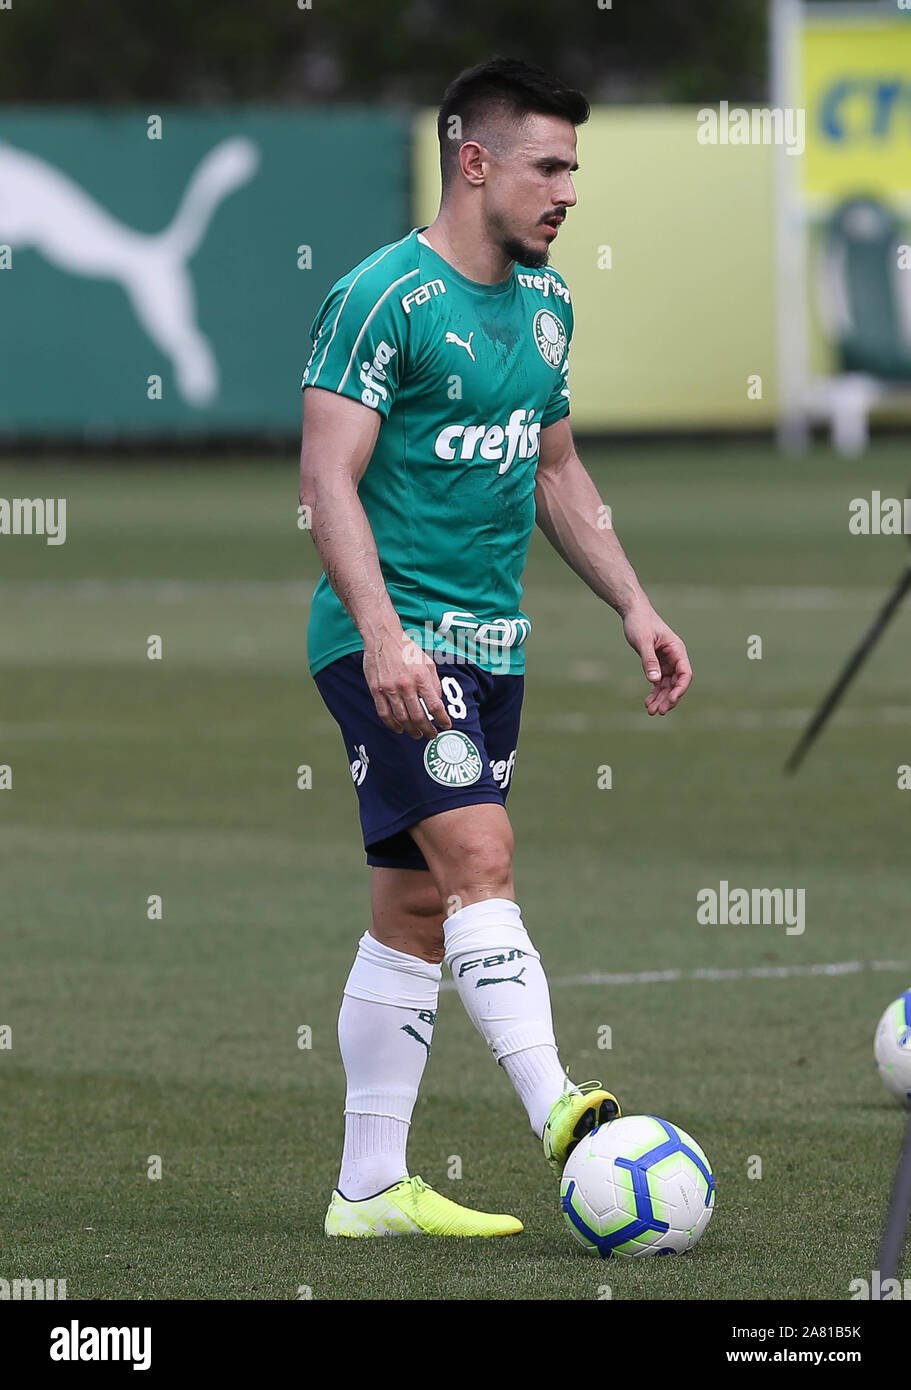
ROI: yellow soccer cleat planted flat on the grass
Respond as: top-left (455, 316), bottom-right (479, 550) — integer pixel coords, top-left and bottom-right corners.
top-left (324, 1177), bottom-right (524, 1236)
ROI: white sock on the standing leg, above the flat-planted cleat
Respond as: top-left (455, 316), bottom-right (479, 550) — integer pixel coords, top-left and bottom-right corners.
top-left (338, 933), bottom-right (442, 1201)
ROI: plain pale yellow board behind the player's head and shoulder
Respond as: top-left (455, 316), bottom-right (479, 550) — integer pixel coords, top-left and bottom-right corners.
top-left (413, 107), bottom-right (775, 434)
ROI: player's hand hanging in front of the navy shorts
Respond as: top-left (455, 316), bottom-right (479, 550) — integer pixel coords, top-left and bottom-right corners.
top-left (364, 630), bottom-right (452, 738)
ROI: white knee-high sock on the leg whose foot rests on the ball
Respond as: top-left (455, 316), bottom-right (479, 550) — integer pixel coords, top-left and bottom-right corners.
top-left (444, 898), bottom-right (566, 1137)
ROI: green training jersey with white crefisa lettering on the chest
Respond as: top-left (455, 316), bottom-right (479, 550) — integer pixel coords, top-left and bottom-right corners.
top-left (302, 228), bottom-right (573, 674)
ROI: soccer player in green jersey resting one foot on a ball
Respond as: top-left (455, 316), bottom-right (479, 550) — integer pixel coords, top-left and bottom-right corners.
top-left (300, 58), bottom-right (691, 1236)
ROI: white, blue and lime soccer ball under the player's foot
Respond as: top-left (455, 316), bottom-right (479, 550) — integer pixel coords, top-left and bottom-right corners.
top-left (561, 1115), bottom-right (715, 1259)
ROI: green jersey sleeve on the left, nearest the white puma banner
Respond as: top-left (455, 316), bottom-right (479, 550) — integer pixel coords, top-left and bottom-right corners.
top-left (300, 269), bottom-right (408, 420)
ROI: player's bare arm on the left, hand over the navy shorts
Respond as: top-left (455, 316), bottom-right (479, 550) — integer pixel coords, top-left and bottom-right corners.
top-left (300, 386), bottom-right (452, 738)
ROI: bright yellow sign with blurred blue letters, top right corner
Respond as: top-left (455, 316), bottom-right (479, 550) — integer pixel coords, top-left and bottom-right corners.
top-left (798, 8), bottom-right (911, 202)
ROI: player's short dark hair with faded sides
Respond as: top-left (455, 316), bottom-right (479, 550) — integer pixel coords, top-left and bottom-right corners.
top-left (437, 58), bottom-right (590, 189)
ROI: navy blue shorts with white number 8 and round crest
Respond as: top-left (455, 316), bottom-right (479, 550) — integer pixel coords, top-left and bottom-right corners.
top-left (313, 651), bottom-right (524, 869)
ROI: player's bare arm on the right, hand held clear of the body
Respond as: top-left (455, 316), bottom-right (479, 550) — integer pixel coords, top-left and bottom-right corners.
top-left (534, 416), bottom-right (693, 714)
